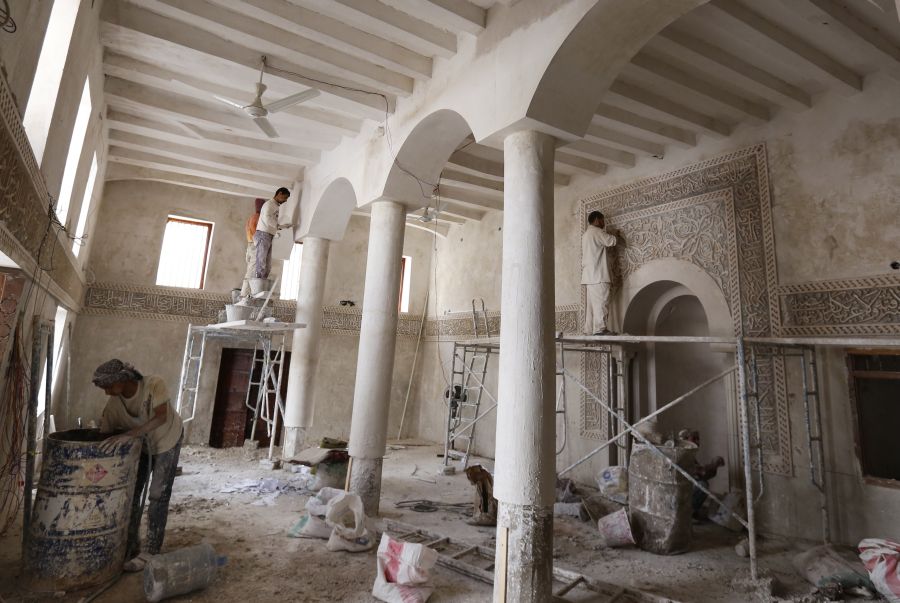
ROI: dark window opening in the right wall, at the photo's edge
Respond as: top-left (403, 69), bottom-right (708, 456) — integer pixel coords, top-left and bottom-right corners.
top-left (848, 351), bottom-right (900, 486)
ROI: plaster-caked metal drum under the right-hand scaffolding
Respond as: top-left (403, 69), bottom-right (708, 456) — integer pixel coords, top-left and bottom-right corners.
top-left (628, 444), bottom-right (697, 555)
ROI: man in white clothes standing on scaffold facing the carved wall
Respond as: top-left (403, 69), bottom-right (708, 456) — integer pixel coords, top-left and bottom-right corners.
top-left (581, 211), bottom-right (617, 335)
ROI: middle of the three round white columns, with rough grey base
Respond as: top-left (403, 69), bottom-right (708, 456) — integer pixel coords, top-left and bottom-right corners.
top-left (350, 201), bottom-right (406, 517)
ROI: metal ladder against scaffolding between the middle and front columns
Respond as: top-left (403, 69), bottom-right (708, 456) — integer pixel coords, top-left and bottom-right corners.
top-left (444, 343), bottom-right (492, 470)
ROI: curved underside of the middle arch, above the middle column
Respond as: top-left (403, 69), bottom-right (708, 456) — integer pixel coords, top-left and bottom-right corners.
top-left (382, 109), bottom-right (472, 209)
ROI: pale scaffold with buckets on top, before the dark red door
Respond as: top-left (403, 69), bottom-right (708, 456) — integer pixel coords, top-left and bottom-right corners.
top-left (175, 320), bottom-right (306, 460)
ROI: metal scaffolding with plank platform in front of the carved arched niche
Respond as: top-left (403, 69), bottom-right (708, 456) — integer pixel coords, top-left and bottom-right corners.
top-left (442, 333), bottom-right (900, 580)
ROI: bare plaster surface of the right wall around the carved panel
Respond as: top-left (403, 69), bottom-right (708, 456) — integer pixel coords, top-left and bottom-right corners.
top-left (406, 74), bottom-right (900, 544)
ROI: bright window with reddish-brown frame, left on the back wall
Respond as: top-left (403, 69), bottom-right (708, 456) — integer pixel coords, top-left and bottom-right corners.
top-left (156, 216), bottom-right (213, 289)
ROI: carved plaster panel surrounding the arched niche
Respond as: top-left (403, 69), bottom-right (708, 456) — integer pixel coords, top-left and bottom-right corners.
top-left (581, 145), bottom-right (791, 474)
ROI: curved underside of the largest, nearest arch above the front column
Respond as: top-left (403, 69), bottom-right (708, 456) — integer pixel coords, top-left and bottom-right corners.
top-left (527, 0), bottom-right (709, 137)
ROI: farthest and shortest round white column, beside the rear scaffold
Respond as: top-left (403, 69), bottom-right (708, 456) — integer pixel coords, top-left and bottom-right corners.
top-left (284, 237), bottom-right (330, 457)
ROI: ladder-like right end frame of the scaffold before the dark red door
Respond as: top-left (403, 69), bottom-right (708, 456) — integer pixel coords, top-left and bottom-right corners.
top-left (244, 334), bottom-right (285, 459)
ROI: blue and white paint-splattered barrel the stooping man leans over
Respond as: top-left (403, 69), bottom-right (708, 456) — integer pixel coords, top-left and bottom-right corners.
top-left (25, 429), bottom-right (141, 591)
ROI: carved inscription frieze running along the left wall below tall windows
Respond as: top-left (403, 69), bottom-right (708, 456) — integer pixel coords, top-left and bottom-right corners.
top-left (0, 77), bottom-right (84, 308)
